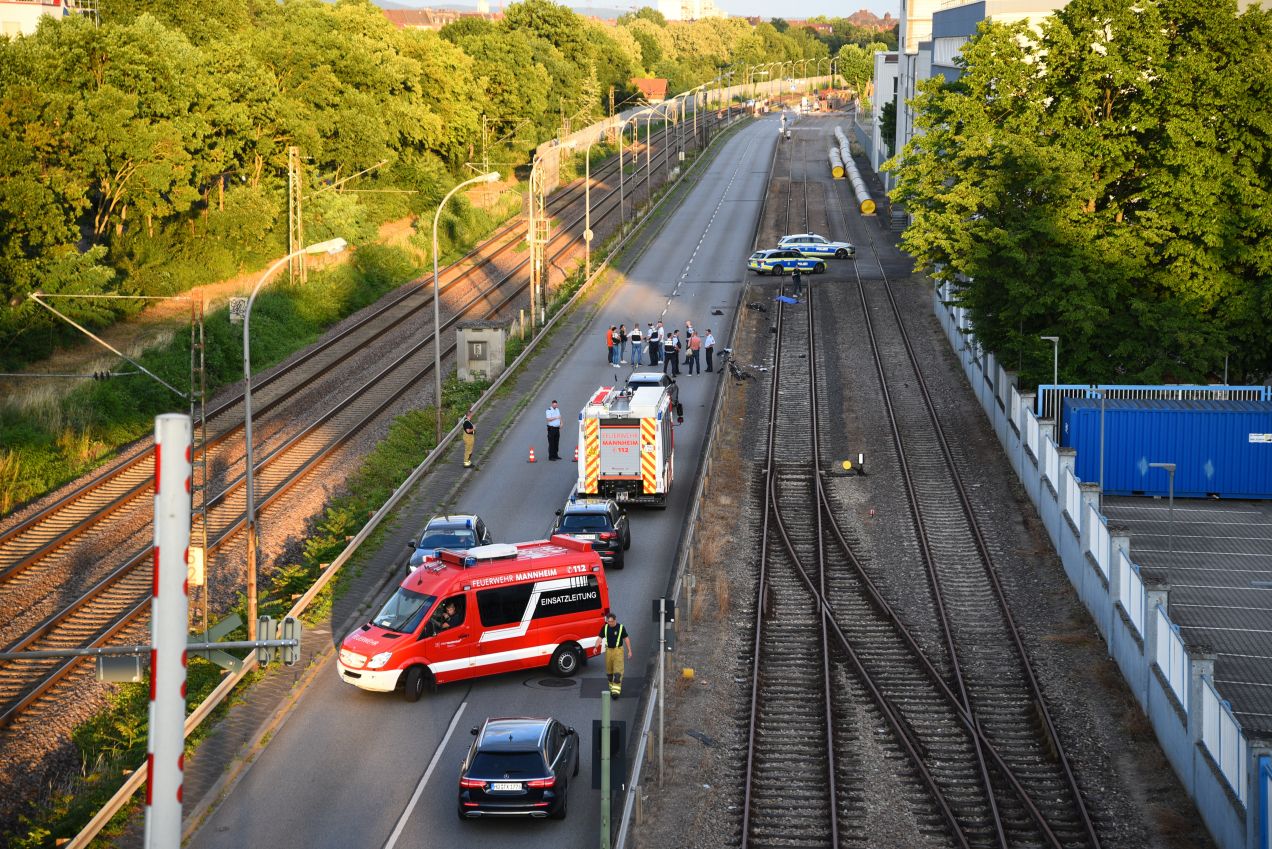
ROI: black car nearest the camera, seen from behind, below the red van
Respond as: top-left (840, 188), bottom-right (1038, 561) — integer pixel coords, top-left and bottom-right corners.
top-left (459, 717), bottom-right (579, 820)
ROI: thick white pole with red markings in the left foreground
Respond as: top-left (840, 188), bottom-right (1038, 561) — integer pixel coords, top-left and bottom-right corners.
top-left (146, 412), bottom-right (193, 849)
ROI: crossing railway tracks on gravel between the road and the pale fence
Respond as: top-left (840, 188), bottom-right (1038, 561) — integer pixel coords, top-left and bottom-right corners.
top-left (742, 127), bottom-right (1100, 848)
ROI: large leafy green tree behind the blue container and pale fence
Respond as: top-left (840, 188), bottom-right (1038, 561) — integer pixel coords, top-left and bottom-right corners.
top-left (889, 0), bottom-right (1272, 383)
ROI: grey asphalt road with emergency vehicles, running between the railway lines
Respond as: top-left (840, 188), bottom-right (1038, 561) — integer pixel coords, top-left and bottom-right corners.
top-left (190, 117), bottom-right (777, 849)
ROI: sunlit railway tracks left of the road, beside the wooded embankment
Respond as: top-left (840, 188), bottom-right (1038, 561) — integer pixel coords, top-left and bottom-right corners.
top-left (0, 104), bottom-right (737, 728)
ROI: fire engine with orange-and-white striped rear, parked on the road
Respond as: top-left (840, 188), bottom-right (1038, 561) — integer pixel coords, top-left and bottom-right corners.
top-left (575, 373), bottom-right (675, 508)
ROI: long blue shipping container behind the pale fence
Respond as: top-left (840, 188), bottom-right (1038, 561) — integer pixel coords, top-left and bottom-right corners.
top-left (1060, 398), bottom-right (1272, 499)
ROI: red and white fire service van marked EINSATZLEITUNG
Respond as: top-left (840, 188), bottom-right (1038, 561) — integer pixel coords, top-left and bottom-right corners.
top-left (338, 535), bottom-right (609, 701)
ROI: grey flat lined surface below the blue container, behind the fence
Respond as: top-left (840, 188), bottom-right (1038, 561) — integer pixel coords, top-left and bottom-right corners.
top-left (1104, 496), bottom-right (1272, 736)
